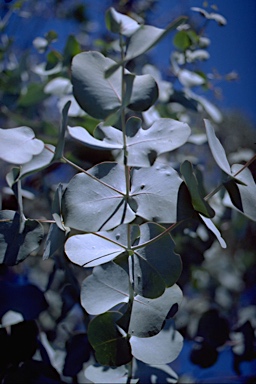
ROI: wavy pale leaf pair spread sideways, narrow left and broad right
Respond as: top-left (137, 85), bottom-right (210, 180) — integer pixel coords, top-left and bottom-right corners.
top-left (68, 117), bottom-right (191, 167)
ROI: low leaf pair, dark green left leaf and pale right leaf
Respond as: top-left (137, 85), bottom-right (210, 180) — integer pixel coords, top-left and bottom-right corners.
top-left (88, 312), bottom-right (183, 366)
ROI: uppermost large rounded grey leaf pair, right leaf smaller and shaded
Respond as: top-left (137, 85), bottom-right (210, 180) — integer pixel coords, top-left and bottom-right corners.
top-left (72, 51), bottom-right (158, 120)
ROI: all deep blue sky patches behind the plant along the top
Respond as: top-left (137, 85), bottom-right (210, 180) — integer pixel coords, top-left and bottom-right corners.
top-left (3, 0), bottom-right (256, 125)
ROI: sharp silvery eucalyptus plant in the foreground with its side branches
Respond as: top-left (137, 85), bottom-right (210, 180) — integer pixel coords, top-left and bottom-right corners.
top-left (0, 8), bottom-right (256, 383)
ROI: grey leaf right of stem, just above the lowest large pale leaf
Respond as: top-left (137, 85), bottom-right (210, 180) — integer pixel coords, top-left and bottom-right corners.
top-left (128, 284), bottom-right (182, 336)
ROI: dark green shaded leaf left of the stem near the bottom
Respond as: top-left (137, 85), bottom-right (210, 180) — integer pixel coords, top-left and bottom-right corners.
top-left (88, 312), bottom-right (132, 366)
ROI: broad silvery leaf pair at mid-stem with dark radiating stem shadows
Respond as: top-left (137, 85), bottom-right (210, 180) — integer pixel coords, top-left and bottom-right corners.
top-left (62, 163), bottom-right (182, 232)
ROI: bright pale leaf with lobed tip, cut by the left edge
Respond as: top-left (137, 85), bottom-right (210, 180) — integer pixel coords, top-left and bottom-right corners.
top-left (0, 127), bottom-right (44, 164)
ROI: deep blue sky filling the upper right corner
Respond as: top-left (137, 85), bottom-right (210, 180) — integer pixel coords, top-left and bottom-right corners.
top-left (144, 0), bottom-right (256, 125)
